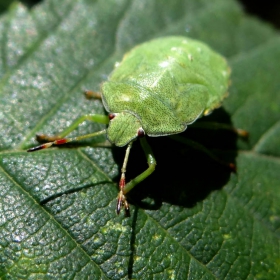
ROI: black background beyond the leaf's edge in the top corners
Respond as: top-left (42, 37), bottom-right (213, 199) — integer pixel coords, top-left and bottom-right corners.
top-left (0, 0), bottom-right (280, 29)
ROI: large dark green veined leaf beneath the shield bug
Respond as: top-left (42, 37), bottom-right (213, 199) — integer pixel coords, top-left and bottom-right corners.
top-left (0, 0), bottom-right (280, 279)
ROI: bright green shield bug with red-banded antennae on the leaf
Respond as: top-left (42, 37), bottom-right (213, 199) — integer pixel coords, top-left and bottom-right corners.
top-left (28, 36), bottom-right (230, 214)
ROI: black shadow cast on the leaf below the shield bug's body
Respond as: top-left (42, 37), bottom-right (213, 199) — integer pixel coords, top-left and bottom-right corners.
top-left (114, 108), bottom-right (244, 210)
